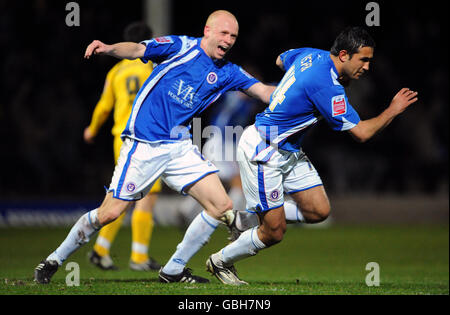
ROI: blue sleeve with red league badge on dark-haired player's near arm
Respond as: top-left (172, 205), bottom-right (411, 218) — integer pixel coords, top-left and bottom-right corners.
top-left (310, 86), bottom-right (361, 131)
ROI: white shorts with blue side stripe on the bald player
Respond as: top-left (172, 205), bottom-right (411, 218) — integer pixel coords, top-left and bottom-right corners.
top-left (108, 138), bottom-right (218, 201)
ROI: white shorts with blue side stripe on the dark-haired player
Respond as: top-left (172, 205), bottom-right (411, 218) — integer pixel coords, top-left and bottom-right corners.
top-left (237, 125), bottom-right (323, 212)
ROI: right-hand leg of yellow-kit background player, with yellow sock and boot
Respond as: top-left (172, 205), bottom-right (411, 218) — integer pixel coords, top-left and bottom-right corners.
top-left (130, 179), bottom-right (161, 271)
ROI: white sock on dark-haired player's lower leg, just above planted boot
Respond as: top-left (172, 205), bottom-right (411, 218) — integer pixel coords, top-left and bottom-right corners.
top-left (221, 227), bottom-right (266, 265)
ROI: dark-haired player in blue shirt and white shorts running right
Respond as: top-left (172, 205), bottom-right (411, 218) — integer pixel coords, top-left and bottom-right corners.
top-left (206, 27), bottom-right (417, 285)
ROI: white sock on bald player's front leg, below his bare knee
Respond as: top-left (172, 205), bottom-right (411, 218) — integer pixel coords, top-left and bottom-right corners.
top-left (162, 211), bottom-right (221, 275)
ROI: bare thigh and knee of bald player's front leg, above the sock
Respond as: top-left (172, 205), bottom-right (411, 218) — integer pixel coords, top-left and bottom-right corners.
top-left (186, 173), bottom-right (233, 219)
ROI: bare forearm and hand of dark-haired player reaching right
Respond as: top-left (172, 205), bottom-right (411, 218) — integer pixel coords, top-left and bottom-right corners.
top-left (349, 88), bottom-right (418, 142)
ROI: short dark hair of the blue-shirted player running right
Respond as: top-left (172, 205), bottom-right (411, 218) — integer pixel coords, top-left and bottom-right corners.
top-left (330, 26), bottom-right (375, 58)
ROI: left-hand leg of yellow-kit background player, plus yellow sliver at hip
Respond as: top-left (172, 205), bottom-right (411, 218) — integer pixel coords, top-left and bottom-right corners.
top-left (88, 136), bottom-right (127, 270)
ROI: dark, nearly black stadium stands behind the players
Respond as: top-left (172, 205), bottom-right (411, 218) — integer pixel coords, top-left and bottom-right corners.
top-left (0, 0), bottom-right (448, 211)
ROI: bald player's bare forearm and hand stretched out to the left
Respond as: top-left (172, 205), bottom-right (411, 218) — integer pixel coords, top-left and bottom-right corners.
top-left (84, 40), bottom-right (145, 60)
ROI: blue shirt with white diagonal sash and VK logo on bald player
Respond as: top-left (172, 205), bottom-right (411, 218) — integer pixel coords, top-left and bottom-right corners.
top-left (122, 36), bottom-right (259, 142)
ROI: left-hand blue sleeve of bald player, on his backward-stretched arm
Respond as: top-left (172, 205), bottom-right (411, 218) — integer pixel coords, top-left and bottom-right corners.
top-left (141, 36), bottom-right (182, 63)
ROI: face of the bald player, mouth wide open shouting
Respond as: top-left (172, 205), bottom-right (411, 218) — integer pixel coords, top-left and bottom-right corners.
top-left (205, 17), bottom-right (239, 59)
